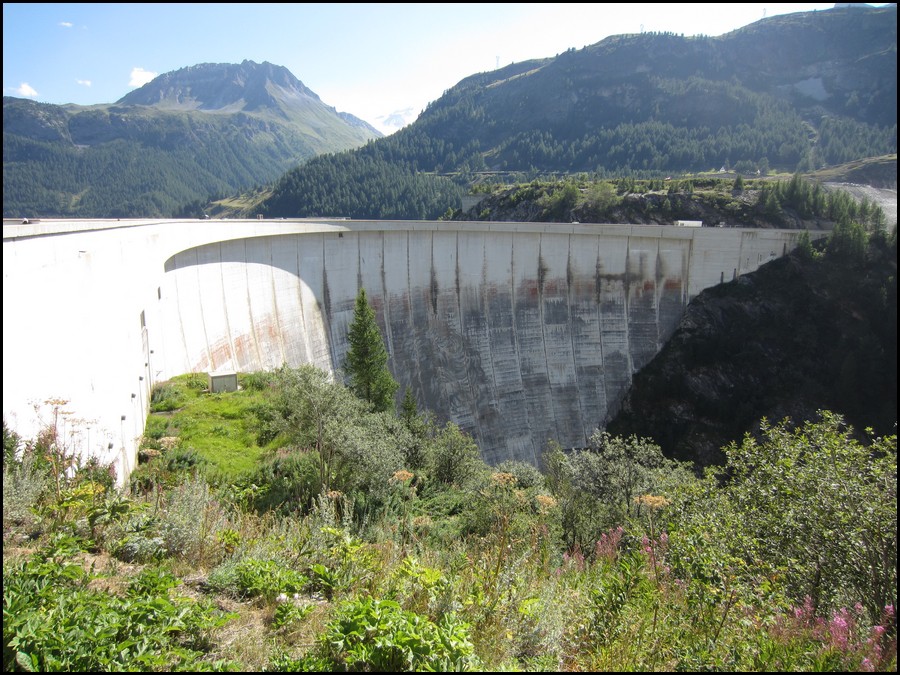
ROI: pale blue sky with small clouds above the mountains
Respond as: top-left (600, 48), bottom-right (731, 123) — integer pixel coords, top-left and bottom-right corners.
top-left (3, 3), bottom-right (864, 133)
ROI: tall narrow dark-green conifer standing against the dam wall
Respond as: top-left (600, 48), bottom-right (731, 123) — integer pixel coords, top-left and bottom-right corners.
top-left (344, 288), bottom-right (400, 412)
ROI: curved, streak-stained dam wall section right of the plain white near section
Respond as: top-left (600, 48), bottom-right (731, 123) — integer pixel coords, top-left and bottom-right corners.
top-left (156, 223), bottom-right (799, 465)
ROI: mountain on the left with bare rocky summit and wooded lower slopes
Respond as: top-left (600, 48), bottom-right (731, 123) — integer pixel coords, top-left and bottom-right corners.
top-left (3, 61), bottom-right (381, 218)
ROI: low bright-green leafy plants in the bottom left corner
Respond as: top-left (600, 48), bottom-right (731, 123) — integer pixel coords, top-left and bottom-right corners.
top-left (3, 555), bottom-right (231, 672)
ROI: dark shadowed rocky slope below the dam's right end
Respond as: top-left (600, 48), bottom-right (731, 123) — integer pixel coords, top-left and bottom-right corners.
top-left (607, 241), bottom-right (897, 466)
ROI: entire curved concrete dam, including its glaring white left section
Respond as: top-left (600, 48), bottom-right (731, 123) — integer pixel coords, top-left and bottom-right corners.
top-left (3, 220), bottom-right (816, 480)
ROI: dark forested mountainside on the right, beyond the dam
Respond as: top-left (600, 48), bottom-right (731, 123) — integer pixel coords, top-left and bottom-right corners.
top-left (254, 5), bottom-right (897, 218)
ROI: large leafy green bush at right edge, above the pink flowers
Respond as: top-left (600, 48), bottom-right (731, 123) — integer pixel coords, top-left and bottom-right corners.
top-left (725, 412), bottom-right (897, 621)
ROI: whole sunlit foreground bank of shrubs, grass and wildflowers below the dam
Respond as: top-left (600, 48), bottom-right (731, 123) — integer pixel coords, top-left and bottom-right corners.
top-left (3, 366), bottom-right (897, 672)
